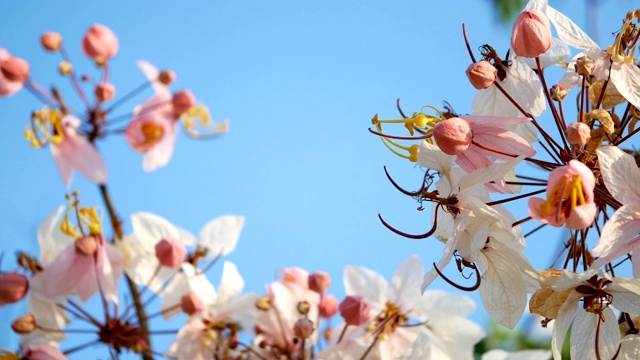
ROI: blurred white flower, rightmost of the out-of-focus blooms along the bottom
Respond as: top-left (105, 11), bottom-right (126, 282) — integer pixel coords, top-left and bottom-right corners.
top-left (344, 256), bottom-right (484, 359)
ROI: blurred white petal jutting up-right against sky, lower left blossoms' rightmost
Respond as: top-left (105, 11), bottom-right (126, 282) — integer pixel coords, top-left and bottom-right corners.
top-left (198, 215), bottom-right (244, 258)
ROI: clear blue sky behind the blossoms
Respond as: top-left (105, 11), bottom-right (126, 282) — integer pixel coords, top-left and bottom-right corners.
top-left (0, 0), bottom-right (633, 356)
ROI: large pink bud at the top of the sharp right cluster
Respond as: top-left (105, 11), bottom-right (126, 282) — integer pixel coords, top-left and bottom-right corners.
top-left (511, 10), bottom-right (551, 58)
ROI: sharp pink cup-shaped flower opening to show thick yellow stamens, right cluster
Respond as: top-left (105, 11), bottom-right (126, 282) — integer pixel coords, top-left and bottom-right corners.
top-left (529, 160), bottom-right (596, 230)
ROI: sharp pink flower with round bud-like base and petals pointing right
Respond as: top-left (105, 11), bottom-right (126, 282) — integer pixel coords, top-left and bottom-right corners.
top-left (433, 116), bottom-right (536, 173)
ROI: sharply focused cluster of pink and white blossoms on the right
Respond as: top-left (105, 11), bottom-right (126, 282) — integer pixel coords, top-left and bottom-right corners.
top-left (371, 0), bottom-right (640, 359)
